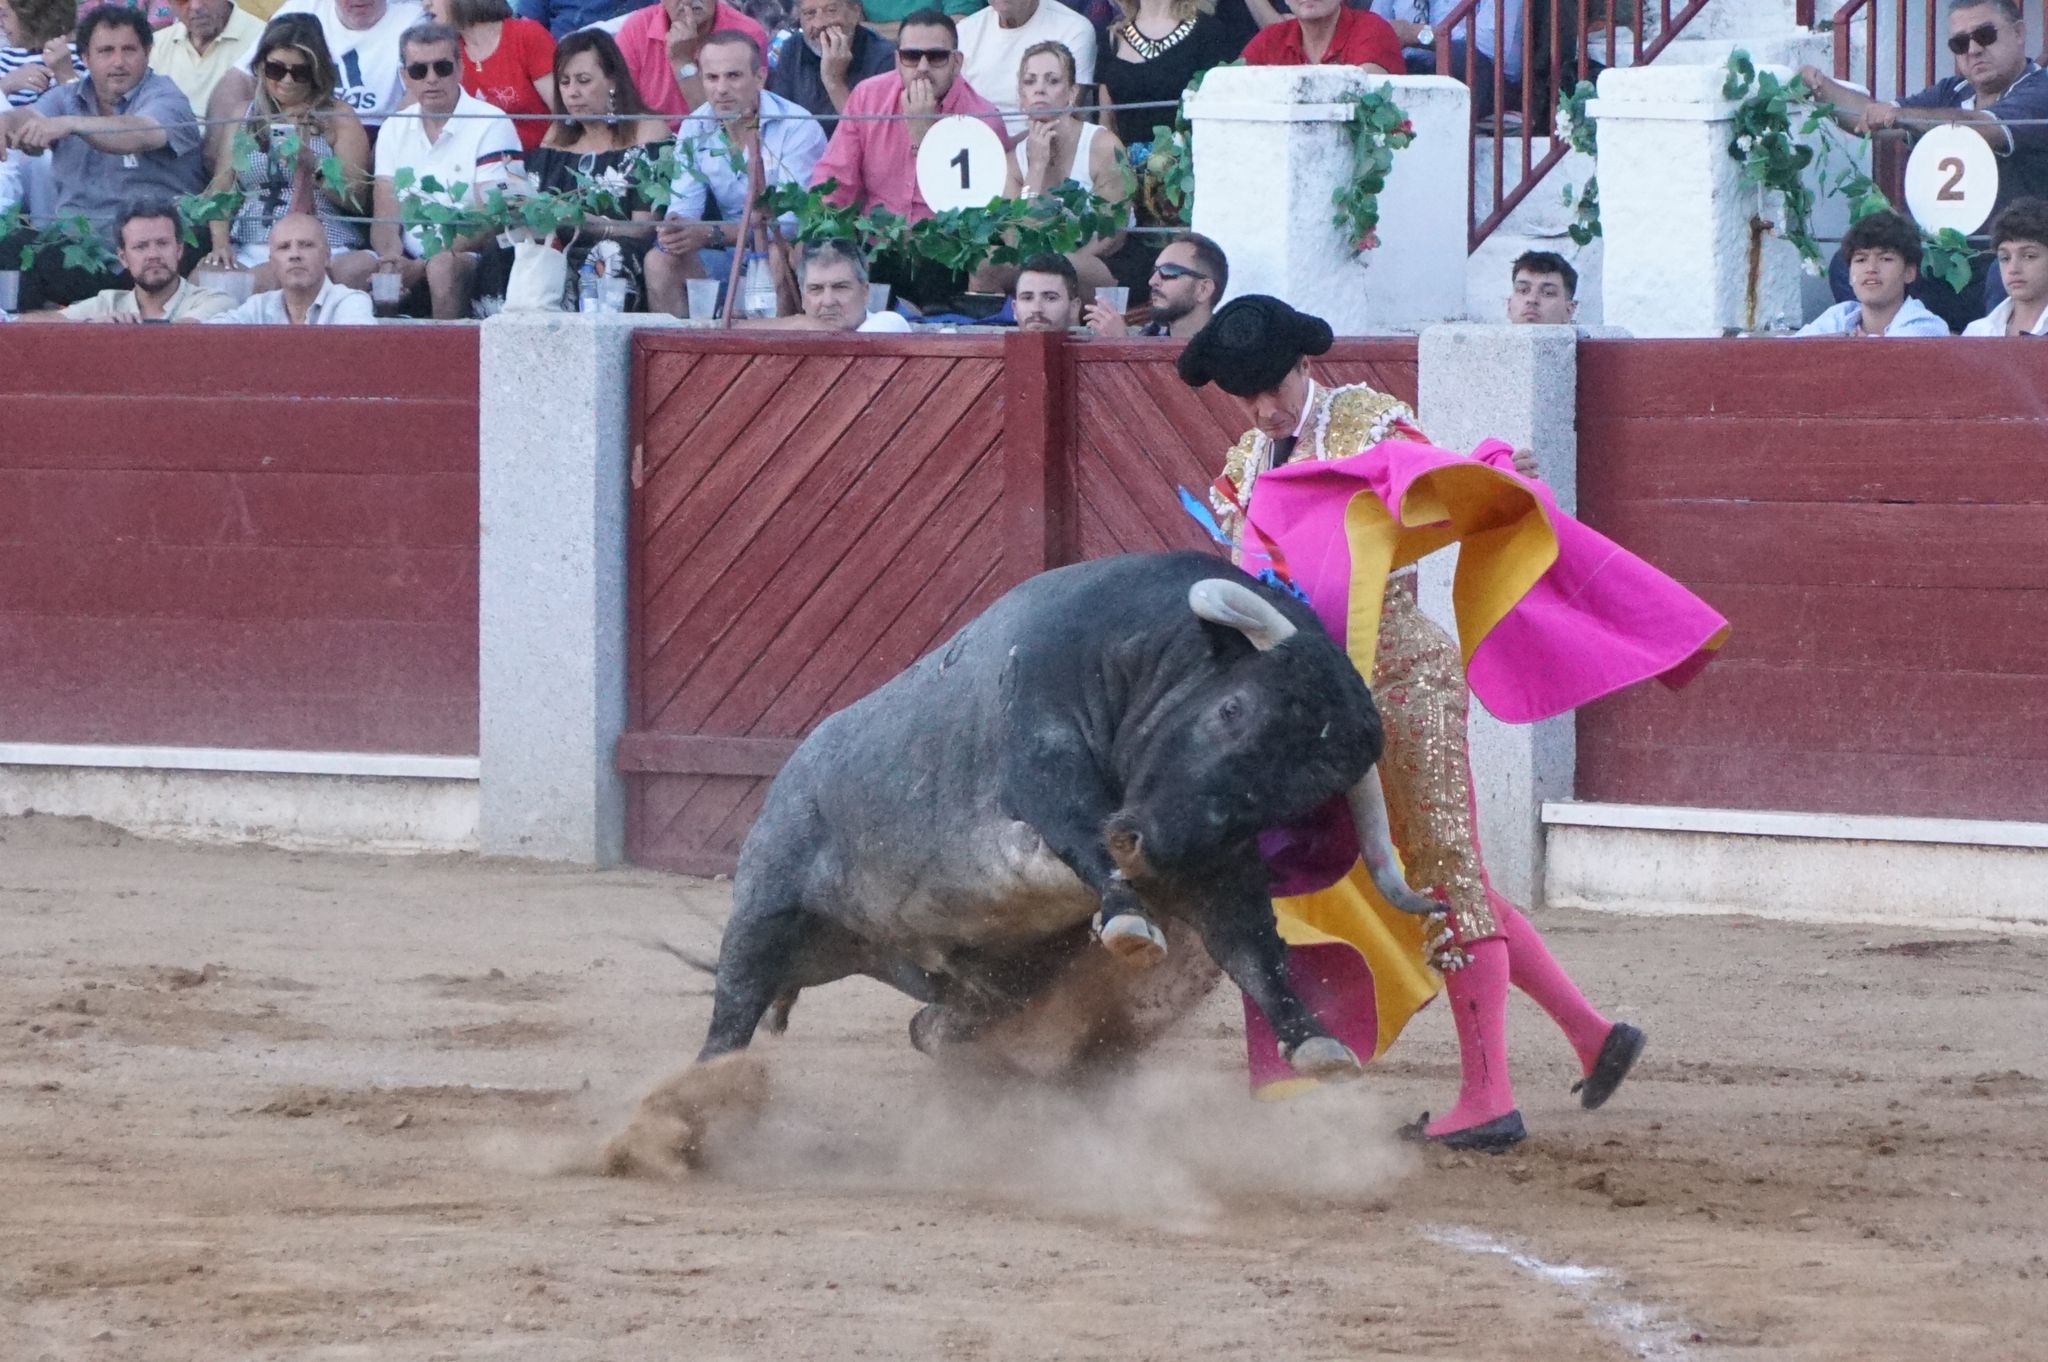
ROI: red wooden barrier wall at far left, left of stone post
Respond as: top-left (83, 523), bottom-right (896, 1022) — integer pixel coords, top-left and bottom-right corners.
top-left (0, 326), bottom-right (477, 754)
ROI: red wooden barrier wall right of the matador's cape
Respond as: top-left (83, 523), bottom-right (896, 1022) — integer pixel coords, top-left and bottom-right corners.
top-left (1577, 340), bottom-right (2048, 819)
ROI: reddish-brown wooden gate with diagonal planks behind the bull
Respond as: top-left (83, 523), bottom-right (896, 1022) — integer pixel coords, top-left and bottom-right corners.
top-left (618, 332), bottom-right (1415, 875)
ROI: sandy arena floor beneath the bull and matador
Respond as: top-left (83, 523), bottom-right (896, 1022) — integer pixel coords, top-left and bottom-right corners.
top-left (0, 819), bottom-right (2048, 1362)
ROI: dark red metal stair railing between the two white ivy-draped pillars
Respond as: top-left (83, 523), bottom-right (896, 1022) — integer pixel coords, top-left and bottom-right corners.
top-left (1436, 0), bottom-right (1712, 250)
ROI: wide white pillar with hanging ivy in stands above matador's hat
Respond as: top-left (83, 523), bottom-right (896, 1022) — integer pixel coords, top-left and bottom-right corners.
top-left (1188, 66), bottom-right (1473, 336)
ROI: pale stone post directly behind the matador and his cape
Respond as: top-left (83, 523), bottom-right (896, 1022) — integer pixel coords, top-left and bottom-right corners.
top-left (1417, 326), bottom-right (1579, 905)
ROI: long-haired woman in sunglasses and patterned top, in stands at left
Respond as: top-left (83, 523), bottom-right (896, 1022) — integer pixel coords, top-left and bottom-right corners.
top-left (205, 14), bottom-right (371, 282)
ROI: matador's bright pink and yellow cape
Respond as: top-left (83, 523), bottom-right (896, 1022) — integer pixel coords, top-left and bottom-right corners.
top-left (1241, 440), bottom-right (1729, 1096)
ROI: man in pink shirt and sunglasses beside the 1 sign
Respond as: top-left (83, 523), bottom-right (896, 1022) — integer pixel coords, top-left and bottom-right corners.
top-left (811, 8), bottom-right (1010, 221)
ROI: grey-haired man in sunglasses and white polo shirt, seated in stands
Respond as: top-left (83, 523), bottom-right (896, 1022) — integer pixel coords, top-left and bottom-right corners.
top-left (334, 18), bottom-right (520, 322)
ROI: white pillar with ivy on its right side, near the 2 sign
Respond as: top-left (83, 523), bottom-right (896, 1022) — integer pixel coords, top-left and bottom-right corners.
top-left (1589, 61), bottom-right (1802, 338)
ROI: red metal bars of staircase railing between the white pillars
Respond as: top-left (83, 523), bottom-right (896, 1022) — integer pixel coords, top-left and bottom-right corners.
top-left (1436, 0), bottom-right (1708, 250)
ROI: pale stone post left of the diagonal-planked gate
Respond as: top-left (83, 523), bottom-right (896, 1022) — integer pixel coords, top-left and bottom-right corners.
top-left (477, 313), bottom-right (672, 864)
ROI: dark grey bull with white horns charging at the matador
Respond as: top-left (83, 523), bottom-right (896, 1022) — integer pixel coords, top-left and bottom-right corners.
top-left (700, 553), bottom-right (1434, 1075)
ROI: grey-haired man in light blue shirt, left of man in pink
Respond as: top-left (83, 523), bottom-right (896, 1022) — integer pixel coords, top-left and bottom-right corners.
top-left (647, 31), bottom-right (825, 317)
